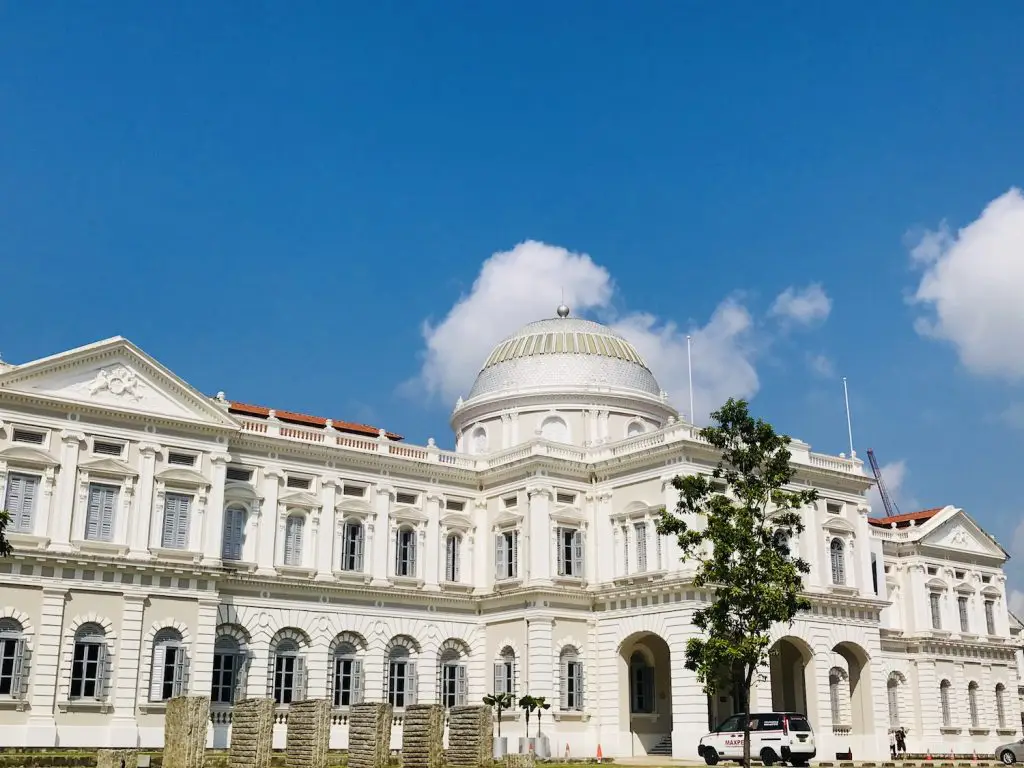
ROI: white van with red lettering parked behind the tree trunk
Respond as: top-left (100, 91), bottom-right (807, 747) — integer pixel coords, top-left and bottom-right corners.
top-left (697, 712), bottom-right (817, 766)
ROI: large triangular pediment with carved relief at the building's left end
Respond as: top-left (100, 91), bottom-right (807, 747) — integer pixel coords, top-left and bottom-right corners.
top-left (0, 337), bottom-right (240, 429)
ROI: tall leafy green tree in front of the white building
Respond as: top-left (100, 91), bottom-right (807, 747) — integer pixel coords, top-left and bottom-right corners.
top-left (658, 397), bottom-right (817, 766)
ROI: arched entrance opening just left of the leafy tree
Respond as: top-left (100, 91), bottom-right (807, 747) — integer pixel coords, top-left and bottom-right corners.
top-left (618, 632), bottom-right (672, 756)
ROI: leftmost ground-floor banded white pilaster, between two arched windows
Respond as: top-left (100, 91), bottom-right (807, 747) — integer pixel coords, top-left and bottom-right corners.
top-left (26, 587), bottom-right (68, 746)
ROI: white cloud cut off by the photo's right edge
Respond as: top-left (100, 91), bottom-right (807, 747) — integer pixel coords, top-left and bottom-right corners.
top-left (911, 188), bottom-right (1024, 380)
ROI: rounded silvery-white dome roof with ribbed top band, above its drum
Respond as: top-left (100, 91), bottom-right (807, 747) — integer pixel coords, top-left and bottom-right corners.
top-left (467, 306), bottom-right (662, 402)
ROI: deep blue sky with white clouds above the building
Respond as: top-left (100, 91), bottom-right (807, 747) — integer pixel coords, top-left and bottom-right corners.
top-left (0, 0), bottom-right (1024, 584)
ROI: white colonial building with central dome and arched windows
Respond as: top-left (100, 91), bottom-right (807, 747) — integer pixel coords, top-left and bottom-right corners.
top-left (0, 307), bottom-right (1021, 758)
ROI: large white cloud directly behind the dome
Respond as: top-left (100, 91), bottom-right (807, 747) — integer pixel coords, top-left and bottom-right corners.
top-left (411, 241), bottom-right (760, 421)
